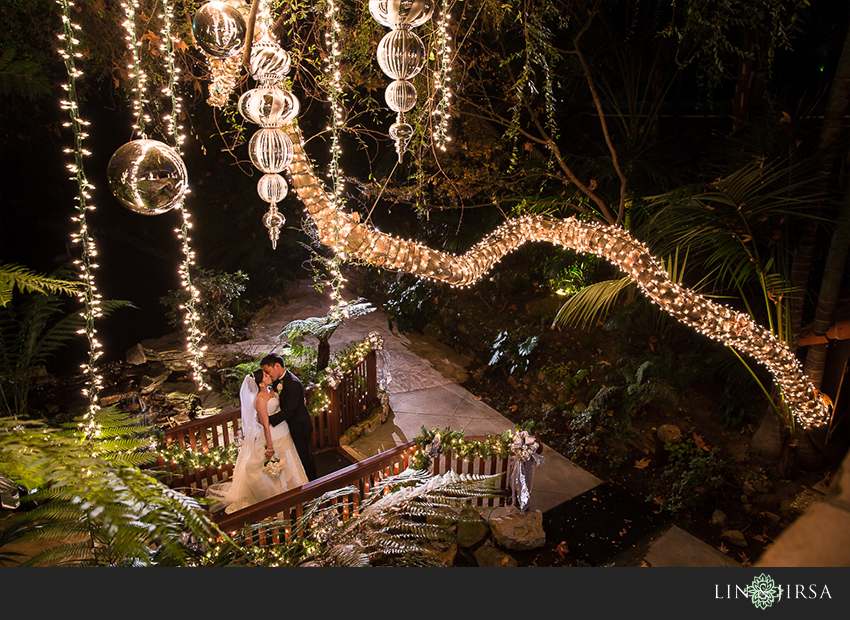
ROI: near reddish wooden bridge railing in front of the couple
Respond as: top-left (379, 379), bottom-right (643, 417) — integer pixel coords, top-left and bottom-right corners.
top-left (214, 437), bottom-right (508, 546)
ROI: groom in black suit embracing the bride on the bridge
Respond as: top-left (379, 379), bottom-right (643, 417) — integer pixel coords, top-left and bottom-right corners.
top-left (260, 353), bottom-right (316, 480)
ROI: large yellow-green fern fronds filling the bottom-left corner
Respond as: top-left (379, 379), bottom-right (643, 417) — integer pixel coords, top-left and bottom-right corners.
top-left (0, 410), bottom-right (227, 566)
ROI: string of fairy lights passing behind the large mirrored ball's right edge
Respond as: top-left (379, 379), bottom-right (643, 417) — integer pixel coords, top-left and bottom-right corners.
top-left (160, 0), bottom-right (210, 389)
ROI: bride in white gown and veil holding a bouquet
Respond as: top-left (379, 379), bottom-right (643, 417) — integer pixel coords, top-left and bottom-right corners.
top-left (206, 370), bottom-right (307, 514)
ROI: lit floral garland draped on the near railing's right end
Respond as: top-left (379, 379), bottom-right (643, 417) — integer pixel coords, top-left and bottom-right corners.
top-left (410, 426), bottom-right (539, 469)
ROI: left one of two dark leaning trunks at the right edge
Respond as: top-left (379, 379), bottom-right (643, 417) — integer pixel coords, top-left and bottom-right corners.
top-left (791, 20), bottom-right (850, 334)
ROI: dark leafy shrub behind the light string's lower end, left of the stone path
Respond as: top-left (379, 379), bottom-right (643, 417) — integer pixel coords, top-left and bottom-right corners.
top-left (159, 269), bottom-right (248, 342)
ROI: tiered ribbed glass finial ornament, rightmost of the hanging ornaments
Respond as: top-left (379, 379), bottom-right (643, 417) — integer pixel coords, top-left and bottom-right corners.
top-left (369, 0), bottom-right (434, 162)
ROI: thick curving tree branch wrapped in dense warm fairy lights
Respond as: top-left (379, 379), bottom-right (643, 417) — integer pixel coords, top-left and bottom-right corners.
top-left (288, 125), bottom-right (829, 427)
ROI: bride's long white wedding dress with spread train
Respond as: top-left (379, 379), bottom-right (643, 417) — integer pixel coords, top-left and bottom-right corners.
top-left (206, 396), bottom-right (307, 514)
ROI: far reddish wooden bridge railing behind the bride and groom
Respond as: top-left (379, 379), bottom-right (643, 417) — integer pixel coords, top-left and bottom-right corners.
top-left (157, 351), bottom-right (378, 495)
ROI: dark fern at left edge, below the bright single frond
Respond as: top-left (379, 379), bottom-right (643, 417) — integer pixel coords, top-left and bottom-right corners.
top-left (0, 278), bottom-right (133, 414)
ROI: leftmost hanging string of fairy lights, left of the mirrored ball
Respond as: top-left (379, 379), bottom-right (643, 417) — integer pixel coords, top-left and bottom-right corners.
top-left (57, 0), bottom-right (103, 439)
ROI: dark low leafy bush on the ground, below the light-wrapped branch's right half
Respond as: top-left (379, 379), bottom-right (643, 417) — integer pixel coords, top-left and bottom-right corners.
top-left (647, 437), bottom-right (729, 514)
